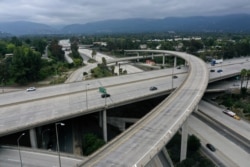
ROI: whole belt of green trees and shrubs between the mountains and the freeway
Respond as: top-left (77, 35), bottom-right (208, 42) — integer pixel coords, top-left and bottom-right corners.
top-left (0, 32), bottom-right (250, 86)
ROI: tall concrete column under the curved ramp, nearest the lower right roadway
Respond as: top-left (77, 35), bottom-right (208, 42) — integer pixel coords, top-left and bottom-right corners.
top-left (180, 120), bottom-right (188, 161)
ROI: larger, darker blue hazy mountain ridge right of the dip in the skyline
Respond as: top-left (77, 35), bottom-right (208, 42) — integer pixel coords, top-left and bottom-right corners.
top-left (62, 14), bottom-right (250, 33)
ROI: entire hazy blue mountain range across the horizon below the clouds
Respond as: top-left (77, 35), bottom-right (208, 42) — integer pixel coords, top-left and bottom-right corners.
top-left (0, 14), bottom-right (250, 36)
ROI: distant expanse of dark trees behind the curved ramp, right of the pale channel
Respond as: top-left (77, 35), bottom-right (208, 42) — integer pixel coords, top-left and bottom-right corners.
top-left (79, 33), bottom-right (250, 60)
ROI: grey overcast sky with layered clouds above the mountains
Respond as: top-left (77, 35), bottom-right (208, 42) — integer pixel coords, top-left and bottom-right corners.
top-left (0, 0), bottom-right (250, 25)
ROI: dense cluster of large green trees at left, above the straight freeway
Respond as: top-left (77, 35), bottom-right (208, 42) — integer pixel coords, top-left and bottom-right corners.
top-left (0, 37), bottom-right (68, 85)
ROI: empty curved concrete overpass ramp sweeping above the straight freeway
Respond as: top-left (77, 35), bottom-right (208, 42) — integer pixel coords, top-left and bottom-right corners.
top-left (79, 50), bottom-right (209, 167)
